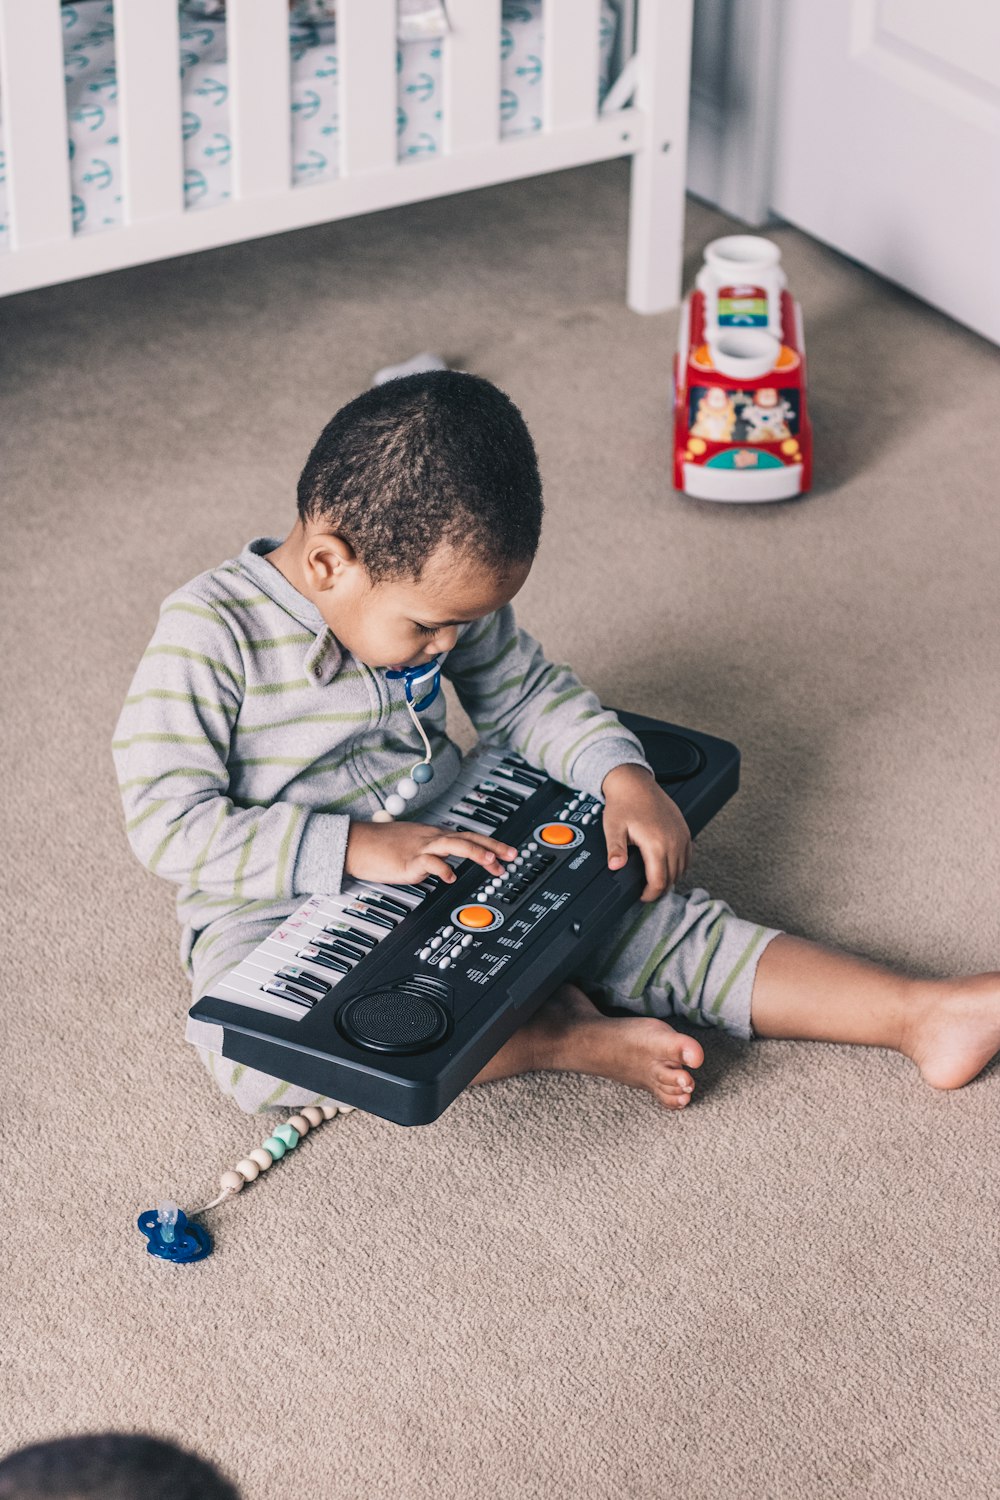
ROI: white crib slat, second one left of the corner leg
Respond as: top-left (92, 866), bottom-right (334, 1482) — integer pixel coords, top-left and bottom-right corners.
top-left (444, 0), bottom-right (501, 152)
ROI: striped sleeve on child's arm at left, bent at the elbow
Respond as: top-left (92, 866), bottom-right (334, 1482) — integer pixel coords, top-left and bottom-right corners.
top-left (112, 591), bottom-right (349, 900)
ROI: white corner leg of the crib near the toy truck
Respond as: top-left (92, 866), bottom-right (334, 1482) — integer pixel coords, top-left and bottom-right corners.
top-left (628, 0), bottom-right (693, 312)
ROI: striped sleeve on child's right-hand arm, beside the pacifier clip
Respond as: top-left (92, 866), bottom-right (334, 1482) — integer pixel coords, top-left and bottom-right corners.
top-left (444, 605), bottom-right (649, 797)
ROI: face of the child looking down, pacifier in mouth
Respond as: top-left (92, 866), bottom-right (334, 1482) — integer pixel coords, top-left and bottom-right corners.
top-left (302, 537), bottom-right (531, 668)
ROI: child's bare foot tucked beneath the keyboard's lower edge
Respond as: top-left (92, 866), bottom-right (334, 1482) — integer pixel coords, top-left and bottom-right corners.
top-left (474, 984), bottom-right (705, 1110)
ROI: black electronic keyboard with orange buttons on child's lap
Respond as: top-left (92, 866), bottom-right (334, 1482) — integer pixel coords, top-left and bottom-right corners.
top-left (190, 713), bottom-right (739, 1125)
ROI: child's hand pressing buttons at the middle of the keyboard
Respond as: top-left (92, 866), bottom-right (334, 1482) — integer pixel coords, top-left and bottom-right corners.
top-left (343, 822), bottom-right (517, 885)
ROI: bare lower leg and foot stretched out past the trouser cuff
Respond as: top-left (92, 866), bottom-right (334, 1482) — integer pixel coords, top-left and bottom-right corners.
top-left (751, 935), bottom-right (1000, 1089)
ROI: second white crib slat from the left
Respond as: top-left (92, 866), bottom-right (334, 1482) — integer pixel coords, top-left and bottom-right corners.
top-left (114, 0), bottom-right (184, 224)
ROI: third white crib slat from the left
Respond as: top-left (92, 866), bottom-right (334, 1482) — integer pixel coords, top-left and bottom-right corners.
top-left (226, 0), bottom-right (292, 198)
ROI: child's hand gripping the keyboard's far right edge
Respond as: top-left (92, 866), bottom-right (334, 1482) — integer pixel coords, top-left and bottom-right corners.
top-left (601, 765), bottom-right (691, 902)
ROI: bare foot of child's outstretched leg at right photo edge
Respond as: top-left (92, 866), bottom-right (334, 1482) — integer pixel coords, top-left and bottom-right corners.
top-left (900, 974), bottom-right (1000, 1089)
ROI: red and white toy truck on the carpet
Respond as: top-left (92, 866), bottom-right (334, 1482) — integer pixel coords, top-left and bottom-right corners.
top-left (673, 234), bottom-right (813, 501)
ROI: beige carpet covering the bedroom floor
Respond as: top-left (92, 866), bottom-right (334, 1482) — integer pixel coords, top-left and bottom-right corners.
top-left (0, 164), bottom-right (1000, 1500)
